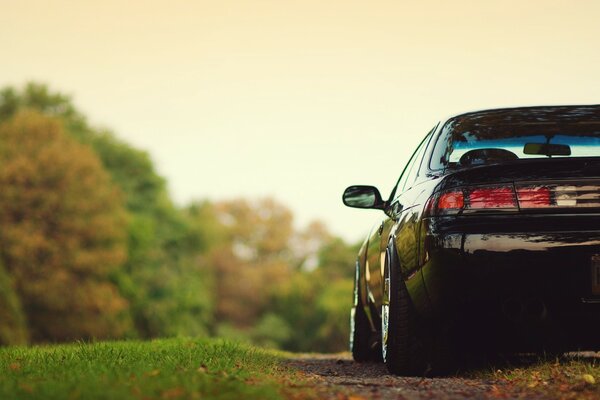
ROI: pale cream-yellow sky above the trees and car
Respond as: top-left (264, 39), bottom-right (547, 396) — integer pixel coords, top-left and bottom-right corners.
top-left (0, 0), bottom-right (600, 241)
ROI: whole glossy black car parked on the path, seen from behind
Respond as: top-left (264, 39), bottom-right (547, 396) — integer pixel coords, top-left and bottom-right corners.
top-left (343, 105), bottom-right (600, 375)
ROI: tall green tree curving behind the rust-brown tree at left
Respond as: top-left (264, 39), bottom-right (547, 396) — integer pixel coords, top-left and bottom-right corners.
top-left (0, 83), bottom-right (216, 337)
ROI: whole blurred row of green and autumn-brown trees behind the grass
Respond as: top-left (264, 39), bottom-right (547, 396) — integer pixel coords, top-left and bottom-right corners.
top-left (0, 83), bottom-right (358, 351)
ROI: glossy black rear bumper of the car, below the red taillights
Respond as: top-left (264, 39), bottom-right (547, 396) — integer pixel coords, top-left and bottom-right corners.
top-left (422, 230), bottom-right (600, 351)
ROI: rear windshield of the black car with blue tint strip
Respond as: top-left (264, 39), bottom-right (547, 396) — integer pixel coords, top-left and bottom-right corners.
top-left (431, 107), bottom-right (600, 169)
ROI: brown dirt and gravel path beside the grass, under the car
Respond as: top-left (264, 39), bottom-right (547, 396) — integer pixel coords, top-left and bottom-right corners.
top-left (289, 354), bottom-right (536, 400)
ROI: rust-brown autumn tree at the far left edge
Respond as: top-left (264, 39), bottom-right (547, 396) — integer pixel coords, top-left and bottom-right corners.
top-left (0, 111), bottom-right (132, 341)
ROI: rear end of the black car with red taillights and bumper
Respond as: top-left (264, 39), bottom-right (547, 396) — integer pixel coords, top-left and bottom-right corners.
top-left (419, 107), bottom-right (600, 351)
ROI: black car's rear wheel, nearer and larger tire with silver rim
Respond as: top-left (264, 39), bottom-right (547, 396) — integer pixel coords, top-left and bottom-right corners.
top-left (381, 247), bottom-right (430, 376)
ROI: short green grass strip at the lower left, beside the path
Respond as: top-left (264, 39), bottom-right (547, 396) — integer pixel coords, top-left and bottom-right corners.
top-left (0, 339), bottom-right (310, 400)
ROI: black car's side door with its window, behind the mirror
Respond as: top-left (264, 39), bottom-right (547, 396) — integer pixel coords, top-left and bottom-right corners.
top-left (365, 132), bottom-right (431, 310)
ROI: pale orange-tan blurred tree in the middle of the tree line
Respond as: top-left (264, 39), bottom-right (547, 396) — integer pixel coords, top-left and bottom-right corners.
top-left (210, 198), bottom-right (293, 328)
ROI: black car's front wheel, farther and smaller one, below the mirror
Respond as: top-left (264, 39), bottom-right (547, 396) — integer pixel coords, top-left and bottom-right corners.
top-left (350, 265), bottom-right (381, 362)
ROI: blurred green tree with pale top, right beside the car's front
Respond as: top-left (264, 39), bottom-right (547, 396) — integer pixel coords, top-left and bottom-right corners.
top-left (270, 228), bottom-right (359, 352)
